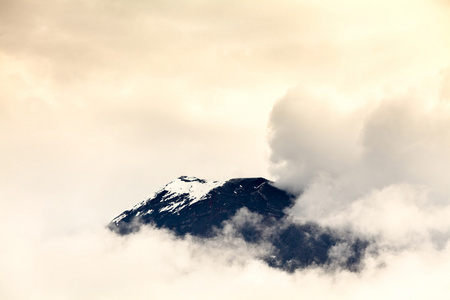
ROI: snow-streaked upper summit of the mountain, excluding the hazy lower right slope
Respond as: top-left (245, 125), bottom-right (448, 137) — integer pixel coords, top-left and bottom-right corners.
top-left (110, 176), bottom-right (293, 236)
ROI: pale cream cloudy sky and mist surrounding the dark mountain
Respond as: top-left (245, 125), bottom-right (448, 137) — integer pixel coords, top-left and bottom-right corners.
top-left (0, 0), bottom-right (450, 299)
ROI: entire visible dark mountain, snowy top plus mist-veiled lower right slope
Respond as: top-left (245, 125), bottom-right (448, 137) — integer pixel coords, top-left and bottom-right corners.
top-left (108, 176), bottom-right (367, 271)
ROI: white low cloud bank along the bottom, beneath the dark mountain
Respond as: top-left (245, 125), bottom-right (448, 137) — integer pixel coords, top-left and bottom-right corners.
top-left (0, 224), bottom-right (450, 299)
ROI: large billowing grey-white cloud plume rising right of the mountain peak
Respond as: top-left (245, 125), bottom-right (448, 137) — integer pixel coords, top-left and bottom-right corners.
top-left (270, 58), bottom-right (450, 278)
